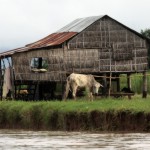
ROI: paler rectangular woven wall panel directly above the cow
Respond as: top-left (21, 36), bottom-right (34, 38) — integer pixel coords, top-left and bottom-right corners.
top-left (64, 49), bottom-right (99, 73)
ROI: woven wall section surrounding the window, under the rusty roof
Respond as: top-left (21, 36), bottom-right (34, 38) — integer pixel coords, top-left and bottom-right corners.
top-left (12, 49), bottom-right (66, 81)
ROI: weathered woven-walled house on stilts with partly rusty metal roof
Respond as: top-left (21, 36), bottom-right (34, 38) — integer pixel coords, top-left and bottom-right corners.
top-left (0, 15), bottom-right (148, 99)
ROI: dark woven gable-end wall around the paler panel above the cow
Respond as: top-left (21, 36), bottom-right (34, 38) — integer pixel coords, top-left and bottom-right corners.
top-left (68, 18), bottom-right (148, 72)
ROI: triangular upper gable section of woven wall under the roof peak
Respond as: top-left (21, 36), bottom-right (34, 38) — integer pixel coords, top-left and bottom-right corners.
top-left (68, 19), bottom-right (146, 49)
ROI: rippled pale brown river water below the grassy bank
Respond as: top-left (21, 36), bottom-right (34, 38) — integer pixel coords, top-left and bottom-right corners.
top-left (0, 130), bottom-right (150, 150)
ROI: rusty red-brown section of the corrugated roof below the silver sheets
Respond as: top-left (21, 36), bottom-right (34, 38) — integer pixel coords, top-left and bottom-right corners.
top-left (26, 32), bottom-right (77, 49)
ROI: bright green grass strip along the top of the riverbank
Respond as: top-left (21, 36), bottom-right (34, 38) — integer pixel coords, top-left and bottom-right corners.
top-left (0, 95), bottom-right (150, 112)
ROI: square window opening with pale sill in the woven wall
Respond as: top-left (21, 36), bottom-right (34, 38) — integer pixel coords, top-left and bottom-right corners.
top-left (30, 57), bottom-right (48, 72)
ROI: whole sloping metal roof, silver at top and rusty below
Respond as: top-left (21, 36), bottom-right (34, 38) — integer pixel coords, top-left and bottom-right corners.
top-left (0, 16), bottom-right (104, 57)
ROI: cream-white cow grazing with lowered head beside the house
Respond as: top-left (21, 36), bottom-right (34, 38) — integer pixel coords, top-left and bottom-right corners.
top-left (64, 73), bottom-right (103, 101)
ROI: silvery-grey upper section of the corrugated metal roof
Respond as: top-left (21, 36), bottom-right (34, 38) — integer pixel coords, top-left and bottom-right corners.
top-left (56, 16), bottom-right (104, 33)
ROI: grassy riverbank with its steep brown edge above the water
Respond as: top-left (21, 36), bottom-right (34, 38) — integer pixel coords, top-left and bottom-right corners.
top-left (0, 95), bottom-right (150, 130)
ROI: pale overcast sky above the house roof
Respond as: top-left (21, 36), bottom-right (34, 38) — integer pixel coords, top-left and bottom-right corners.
top-left (0, 0), bottom-right (150, 52)
